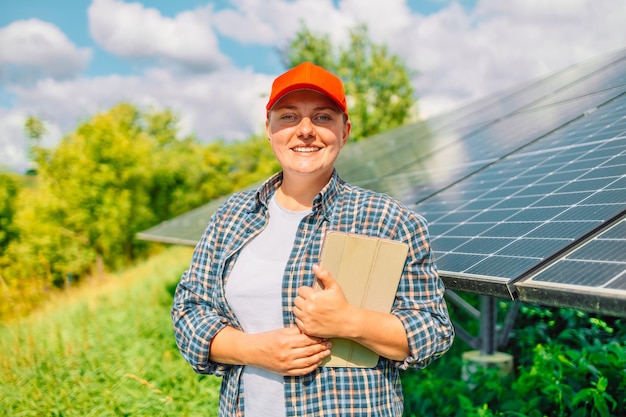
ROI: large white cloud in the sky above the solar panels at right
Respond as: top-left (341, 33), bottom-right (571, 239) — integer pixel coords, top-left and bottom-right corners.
top-left (394, 0), bottom-right (626, 116)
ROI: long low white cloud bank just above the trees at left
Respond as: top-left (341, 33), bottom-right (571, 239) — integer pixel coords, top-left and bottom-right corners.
top-left (0, 69), bottom-right (272, 169)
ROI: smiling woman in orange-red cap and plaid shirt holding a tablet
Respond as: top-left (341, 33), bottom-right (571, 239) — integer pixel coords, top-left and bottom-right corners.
top-left (172, 63), bottom-right (453, 417)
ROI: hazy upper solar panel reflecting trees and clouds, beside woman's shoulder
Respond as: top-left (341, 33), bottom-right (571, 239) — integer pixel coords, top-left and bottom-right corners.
top-left (337, 57), bottom-right (626, 202)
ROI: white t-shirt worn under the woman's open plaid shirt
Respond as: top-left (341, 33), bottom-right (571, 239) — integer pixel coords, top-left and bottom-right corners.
top-left (225, 196), bottom-right (310, 417)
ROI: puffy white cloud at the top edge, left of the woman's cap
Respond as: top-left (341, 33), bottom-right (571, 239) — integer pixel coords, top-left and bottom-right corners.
top-left (88, 0), bottom-right (229, 72)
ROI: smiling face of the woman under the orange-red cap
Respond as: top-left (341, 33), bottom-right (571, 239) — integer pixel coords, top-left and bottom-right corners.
top-left (267, 90), bottom-right (350, 181)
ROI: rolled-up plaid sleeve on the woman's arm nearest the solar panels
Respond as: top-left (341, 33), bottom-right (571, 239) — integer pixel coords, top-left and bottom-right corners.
top-left (392, 214), bottom-right (454, 369)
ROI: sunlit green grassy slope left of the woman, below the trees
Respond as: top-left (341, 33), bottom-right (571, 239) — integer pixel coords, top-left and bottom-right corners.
top-left (0, 247), bottom-right (220, 417)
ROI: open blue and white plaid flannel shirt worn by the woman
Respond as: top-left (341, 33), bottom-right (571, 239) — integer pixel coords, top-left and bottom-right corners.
top-left (172, 167), bottom-right (454, 417)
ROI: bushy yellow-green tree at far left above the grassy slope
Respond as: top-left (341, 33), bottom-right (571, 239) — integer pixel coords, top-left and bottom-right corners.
top-left (9, 104), bottom-right (154, 286)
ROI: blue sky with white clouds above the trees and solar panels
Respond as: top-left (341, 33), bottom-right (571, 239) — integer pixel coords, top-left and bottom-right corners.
top-left (0, 0), bottom-right (626, 171)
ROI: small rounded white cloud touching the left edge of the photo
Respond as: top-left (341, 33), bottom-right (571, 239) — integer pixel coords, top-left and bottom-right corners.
top-left (0, 19), bottom-right (91, 84)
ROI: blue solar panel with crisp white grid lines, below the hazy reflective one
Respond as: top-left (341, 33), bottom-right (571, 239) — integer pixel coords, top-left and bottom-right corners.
top-left (415, 96), bottom-right (626, 298)
